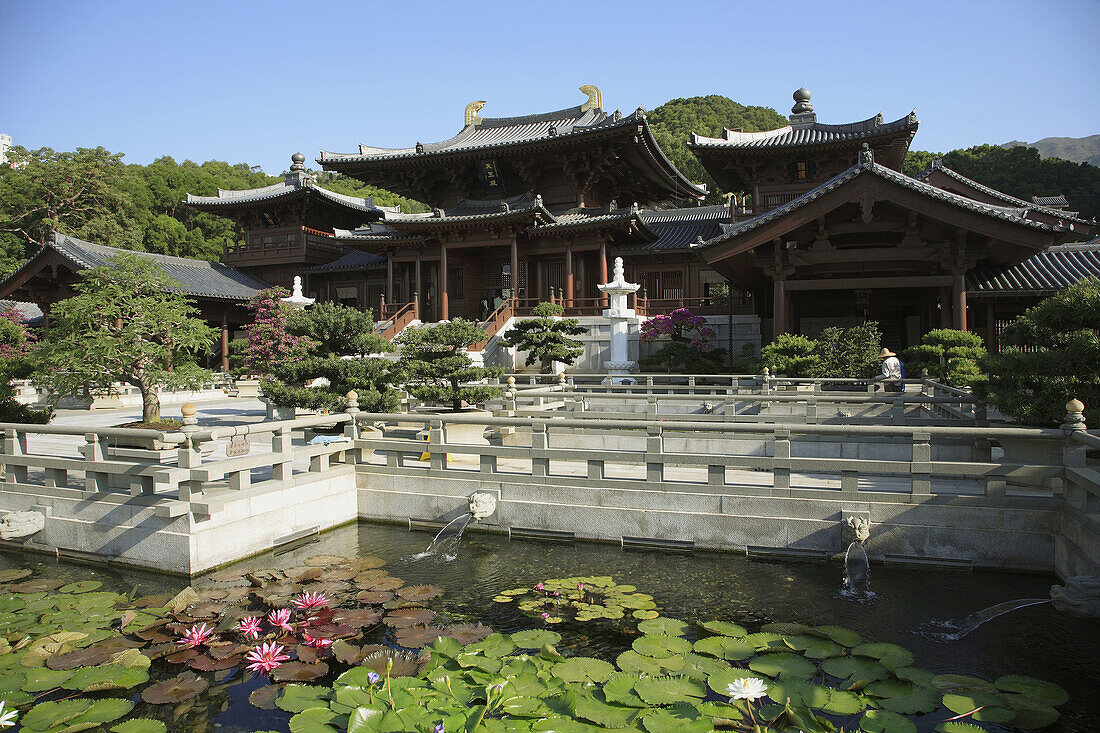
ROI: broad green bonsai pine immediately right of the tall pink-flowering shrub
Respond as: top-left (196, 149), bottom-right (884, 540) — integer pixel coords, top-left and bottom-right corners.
top-left (263, 302), bottom-right (398, 413)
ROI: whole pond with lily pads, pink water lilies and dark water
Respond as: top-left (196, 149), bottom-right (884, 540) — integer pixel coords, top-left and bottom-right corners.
top-left (0, 524), bottom-right (1100, 733)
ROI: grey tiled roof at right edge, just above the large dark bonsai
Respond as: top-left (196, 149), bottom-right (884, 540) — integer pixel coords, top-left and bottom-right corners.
top-left (966, 239), bottom-right (1100, 296)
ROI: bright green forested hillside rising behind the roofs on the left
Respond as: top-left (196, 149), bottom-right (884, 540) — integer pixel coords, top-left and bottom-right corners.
top-left (0, 146), bottom-right (425, 277)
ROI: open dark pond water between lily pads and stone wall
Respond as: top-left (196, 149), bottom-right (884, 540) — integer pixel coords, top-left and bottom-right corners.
top-left (0, 524), bottom-right (1100, 733)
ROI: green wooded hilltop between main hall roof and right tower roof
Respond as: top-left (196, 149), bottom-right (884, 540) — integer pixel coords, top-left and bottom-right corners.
top-left (647, 95), bottom-right (787, 204)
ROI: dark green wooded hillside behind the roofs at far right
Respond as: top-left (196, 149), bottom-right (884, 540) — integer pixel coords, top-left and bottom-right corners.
top-left (902, 145), bottom-right (1100, 219)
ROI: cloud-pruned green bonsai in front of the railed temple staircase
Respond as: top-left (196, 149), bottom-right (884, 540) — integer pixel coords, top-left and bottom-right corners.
top-left (396, 318), bottom-right (504, 412)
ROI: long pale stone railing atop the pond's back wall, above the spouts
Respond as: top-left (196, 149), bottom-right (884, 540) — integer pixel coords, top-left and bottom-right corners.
top-left (356, 402), bottom-right (1082, 503)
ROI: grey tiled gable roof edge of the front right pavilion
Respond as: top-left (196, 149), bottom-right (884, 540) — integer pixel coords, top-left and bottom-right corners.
top-left (705, 160), bottom-right (1063, 247)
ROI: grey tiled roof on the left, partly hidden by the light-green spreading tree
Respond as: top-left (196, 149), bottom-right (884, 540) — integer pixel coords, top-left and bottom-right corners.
top-left (41, 232), bottom-right (270, 300)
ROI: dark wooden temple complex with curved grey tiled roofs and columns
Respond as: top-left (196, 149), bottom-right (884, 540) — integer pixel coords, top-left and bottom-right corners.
top-left (0, 86), bottom-right (1100, 363)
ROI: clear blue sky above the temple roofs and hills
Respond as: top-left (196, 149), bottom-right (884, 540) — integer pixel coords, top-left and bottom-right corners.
top-left (0, 0), bottom-right (1100, 173)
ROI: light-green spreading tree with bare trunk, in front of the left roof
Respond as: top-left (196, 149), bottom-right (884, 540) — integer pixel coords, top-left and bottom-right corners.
top-left (37, 253), bottom-right (217, 424)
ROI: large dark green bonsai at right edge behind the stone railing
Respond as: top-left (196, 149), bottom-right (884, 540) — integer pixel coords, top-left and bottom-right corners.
top-left (981, 280), bottom-right (1100, 427)
